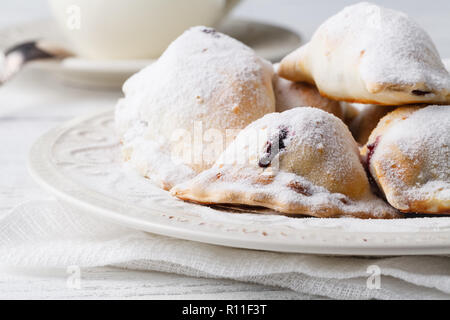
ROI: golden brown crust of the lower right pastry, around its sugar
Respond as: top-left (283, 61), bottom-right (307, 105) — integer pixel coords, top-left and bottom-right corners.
top-left (361, 106), bottom-right (450, 214)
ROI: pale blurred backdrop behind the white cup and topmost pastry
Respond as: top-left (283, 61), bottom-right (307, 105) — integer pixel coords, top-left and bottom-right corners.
top-left (0, 0), bottom-right (450, 57)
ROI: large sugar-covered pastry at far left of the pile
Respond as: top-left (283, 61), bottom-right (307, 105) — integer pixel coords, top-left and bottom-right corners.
top-left (116, 27), bottom-right (275, 189)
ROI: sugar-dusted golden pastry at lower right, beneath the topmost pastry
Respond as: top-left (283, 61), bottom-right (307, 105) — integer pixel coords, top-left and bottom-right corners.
top-left (362, 106), bottom-right (450, 214)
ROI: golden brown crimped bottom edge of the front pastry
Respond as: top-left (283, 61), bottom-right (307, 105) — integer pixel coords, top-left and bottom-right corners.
top-left (171, 168), bottom-right (402, 219)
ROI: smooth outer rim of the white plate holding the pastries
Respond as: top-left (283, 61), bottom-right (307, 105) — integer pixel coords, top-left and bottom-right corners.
top-left (28, 111), bottom-right (450, 256)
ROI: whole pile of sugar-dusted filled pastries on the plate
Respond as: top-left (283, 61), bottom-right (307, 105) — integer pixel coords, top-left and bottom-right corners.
top-left (116, 3), bottom-right (450, 218)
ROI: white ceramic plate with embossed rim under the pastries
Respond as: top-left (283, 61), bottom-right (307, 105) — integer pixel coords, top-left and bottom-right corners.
top-left (29, 112), bottom-right (450, 255)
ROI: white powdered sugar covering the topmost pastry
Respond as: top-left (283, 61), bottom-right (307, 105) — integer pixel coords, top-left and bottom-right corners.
top-left (322, 2), bottom-right (450, 91)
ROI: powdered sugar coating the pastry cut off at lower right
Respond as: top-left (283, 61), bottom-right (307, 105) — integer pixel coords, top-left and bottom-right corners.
top-left (377, 106), bottom-right (450, 202)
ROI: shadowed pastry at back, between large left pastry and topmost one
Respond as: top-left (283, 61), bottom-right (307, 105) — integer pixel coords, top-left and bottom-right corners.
top-left (273, 64), bottom-right (344, 119)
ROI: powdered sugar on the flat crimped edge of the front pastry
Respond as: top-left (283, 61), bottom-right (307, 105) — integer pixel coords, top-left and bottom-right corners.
top-left (176, 167), bottom-right (397, 218)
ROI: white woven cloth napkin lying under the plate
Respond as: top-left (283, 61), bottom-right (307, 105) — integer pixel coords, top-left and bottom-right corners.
top-left (0, 200), bottom-right (450, 299)
